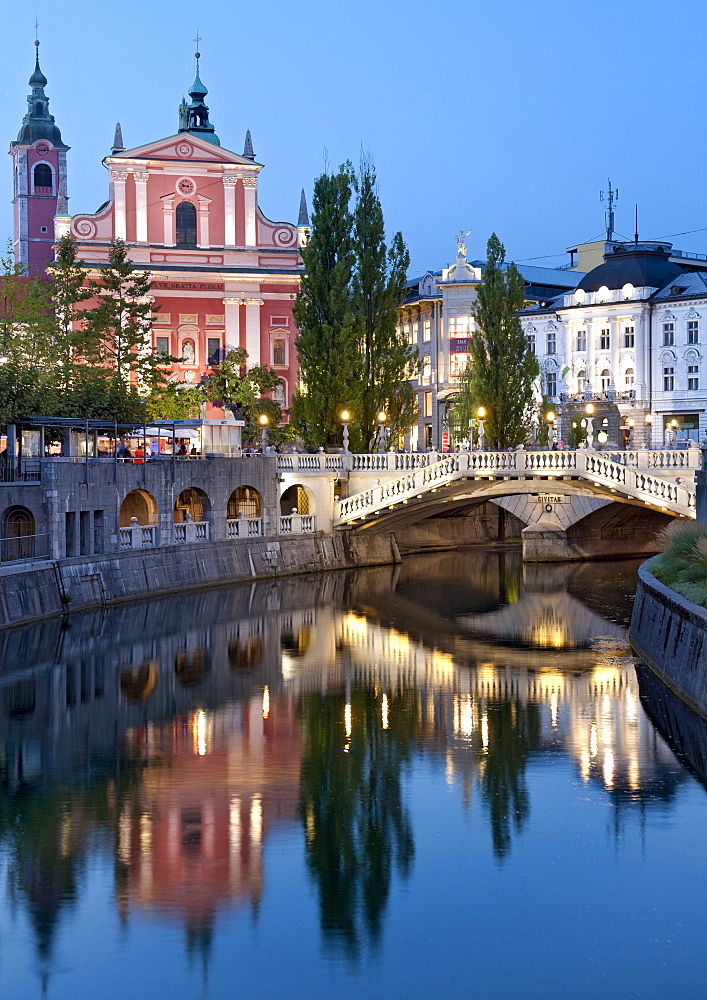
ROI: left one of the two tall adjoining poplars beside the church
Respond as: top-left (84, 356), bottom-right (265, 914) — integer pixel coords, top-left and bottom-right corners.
top-left (292, 163), bottom-right (361, 446)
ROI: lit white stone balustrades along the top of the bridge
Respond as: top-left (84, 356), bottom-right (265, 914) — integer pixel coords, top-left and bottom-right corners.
top-left (334, 449), bottom-right (700, 526)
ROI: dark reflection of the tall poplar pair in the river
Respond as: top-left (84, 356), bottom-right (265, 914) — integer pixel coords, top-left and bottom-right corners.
top-left (300, 690), bottom-right (418, 957)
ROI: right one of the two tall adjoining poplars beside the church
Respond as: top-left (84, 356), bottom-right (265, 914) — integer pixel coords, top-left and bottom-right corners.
top-left (352, 158), bottom-right (418, 450)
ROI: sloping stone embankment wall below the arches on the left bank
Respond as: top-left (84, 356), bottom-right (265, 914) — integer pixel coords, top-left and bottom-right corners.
top-left (0, 532), bottom-right (400, 627)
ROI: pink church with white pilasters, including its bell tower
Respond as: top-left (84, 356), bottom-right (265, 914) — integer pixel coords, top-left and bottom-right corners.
top-left (11, 46), bottom-right (308, 415)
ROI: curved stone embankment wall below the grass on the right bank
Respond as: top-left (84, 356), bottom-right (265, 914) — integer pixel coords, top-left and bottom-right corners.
top-left (630, 562), bottom-right (707, 717)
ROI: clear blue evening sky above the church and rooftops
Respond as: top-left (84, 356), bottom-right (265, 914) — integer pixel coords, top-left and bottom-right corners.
top-left (0, 0), bottom-right (707, 274)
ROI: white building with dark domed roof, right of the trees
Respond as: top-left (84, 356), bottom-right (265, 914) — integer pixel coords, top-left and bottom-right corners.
top-left (521, 242), bottom-right (707, 447)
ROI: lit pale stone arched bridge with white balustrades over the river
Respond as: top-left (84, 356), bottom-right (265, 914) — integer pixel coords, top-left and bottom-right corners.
top-left (278, 448), bottom-right (700, 561)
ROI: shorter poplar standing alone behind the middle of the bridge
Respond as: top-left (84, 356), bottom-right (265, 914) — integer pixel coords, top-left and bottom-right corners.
top-left (455, 233), bottom-right (539, 448)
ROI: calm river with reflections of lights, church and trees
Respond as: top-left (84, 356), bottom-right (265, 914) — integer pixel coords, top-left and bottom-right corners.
top-left (0, 550), bottom-right (707, 1000)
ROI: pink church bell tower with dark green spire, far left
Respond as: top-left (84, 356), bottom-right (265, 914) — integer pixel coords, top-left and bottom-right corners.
top-left (10, 40), bottom-right (69, 274)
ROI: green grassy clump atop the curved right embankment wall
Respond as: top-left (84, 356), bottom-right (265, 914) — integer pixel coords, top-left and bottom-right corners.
top-left (651, 521), bottom-right (707, 608)
